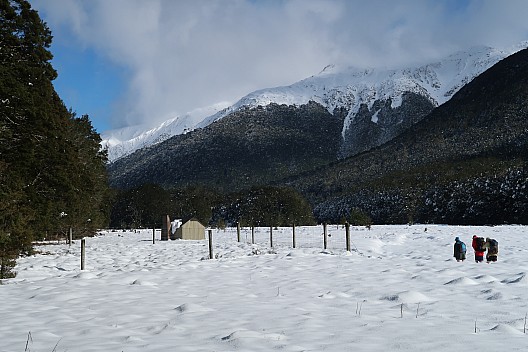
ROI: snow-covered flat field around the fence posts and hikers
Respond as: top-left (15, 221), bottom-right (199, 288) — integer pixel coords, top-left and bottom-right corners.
top-left (0, 225), bottom-right (528, 352)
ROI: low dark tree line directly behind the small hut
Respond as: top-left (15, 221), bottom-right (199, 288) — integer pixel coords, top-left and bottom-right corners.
top-left (110, 184), bottom-right (315, 228)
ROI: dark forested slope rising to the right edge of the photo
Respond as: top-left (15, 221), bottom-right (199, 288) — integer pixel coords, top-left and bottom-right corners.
top-left (286, 49), bottom-right (528, 224)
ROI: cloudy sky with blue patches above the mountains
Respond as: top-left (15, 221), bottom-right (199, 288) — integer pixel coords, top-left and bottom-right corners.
top-left (30, 0), bottom-right (528, 132)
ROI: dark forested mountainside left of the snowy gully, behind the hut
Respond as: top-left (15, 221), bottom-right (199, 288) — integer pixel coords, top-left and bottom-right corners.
top-left (108, 102), bottom-right (343, 192)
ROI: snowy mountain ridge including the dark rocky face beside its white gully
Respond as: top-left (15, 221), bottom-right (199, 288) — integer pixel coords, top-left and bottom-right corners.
top-left (102, 42), bottom-right (528, 161)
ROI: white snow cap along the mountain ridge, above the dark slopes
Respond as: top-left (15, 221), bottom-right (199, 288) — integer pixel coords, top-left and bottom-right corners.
top-left (103, 42), bottom-right (528, 161)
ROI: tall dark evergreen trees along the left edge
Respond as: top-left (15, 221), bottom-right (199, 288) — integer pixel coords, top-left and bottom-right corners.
top-left (0, 0), bottom-right (108, 278)
